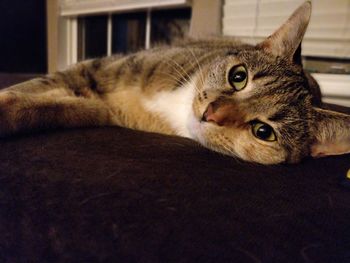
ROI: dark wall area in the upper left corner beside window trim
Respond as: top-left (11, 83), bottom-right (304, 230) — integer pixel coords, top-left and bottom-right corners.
top-left (0, 0), bottom-right (47, 73)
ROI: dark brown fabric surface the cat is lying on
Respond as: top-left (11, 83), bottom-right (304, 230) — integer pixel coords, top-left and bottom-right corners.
top-left (0, 75), bottom-right (350, 263)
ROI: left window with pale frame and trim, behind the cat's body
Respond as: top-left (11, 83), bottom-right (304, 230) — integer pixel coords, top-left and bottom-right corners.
top-left (55, 0), bottom-right (191, 69)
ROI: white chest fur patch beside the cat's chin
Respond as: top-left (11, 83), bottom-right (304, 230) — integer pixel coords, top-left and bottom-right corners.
top-left (143, 83), bottom-right (195, 137)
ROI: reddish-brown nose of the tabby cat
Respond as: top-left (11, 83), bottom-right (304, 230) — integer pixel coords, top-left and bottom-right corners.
top-left (202, 102), bottom-right (233, 126)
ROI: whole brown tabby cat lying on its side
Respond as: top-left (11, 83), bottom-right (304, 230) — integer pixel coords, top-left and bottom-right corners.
top-left (0, 2), bottom-right (350, 164)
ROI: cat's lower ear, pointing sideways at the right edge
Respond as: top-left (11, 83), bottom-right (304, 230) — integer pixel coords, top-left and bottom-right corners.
top-left (311, 108), bottom-right (350, 157)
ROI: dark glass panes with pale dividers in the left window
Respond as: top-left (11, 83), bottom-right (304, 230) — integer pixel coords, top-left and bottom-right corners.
top-left (78, 8), bottom-right (191, 60)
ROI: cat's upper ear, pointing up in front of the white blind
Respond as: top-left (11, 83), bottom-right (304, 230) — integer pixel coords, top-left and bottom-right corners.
top-left (258, 1), bottom-right (311, 64)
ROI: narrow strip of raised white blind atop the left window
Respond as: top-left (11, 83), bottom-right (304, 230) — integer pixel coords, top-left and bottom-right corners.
top-left (60, 0), bottom-right (188, 16)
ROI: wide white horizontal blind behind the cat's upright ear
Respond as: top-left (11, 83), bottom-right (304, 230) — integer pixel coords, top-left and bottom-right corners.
top-left (222, 0), bottom-right (350, 58)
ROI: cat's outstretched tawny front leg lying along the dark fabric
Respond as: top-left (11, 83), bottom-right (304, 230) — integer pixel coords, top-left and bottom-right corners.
top-left (0, 89), bottom-right (113, 137)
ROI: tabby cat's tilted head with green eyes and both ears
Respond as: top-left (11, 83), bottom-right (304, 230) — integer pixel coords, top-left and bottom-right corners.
top-left (191, 2), bottom-right (350, 164)
